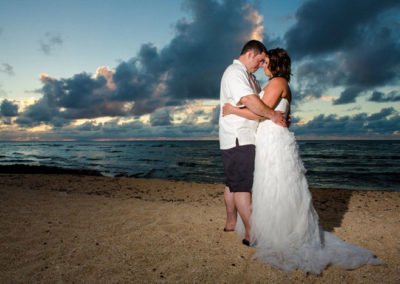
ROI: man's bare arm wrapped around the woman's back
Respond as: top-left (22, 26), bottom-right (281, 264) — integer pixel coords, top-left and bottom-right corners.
top-left (240, 94), bottom-right (287, 127)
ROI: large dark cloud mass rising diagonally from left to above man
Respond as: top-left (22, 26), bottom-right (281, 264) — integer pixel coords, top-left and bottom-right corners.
top-left (17, 0), bottom-right (257, 126)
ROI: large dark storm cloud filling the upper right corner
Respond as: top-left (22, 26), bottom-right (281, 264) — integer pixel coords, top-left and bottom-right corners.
top-left (285, 0), bottom-right (400, 58)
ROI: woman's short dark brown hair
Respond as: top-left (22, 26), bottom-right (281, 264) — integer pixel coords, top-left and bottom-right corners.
top-left (267, 48), bottom-right (292, 82)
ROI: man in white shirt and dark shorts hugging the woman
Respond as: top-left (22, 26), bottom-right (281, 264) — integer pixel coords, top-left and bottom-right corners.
top-left (219, 40), bottom-right (287, 245)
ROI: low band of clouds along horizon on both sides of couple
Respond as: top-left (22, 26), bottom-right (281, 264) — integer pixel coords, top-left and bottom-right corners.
top-left (7, 106), bottom-right (400, 140)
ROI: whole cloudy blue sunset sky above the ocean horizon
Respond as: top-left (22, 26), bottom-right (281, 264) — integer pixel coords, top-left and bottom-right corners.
top-left (0, 0), bottom-right (400, 141)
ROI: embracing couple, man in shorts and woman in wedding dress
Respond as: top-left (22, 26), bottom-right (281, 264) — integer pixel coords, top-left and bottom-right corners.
top-left (219, 40), bottom-right (382, 274)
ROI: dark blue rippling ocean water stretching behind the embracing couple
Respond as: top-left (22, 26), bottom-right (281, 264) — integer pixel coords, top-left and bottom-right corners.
top-left (0, 140), bottom-right (400, 191)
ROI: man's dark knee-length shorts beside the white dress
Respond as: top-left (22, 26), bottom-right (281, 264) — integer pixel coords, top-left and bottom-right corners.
top-left (221, 140), bottom-right (256, 192)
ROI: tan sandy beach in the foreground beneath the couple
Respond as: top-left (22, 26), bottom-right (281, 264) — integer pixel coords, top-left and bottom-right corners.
top-left (0, 173), bottom-right (400, 283)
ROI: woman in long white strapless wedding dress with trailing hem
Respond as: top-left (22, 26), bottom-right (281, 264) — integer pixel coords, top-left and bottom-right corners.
top-left (223, 48), bottom-right (382, 274)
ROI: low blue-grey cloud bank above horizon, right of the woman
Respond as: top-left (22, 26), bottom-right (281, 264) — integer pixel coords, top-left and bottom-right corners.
top-left (292, 108), bottom-right (400, 138)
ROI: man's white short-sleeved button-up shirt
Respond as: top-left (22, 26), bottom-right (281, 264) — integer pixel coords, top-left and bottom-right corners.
top-left (219, 59), bottom-right (261, 150)
